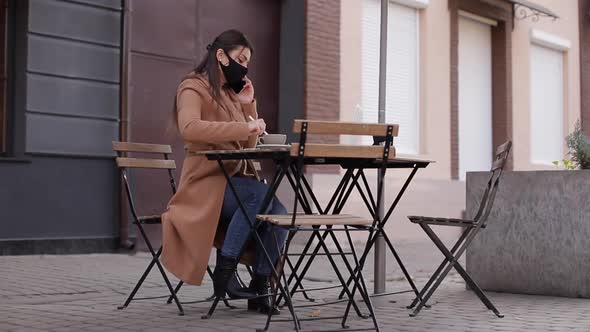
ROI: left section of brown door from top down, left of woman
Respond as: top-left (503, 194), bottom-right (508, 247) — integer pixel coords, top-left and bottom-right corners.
top-left (128, 0), bottom-right (197, 249)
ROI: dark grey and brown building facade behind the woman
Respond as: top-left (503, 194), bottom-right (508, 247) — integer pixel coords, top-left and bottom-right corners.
top-left (0, 0), bottom-right (340, 254)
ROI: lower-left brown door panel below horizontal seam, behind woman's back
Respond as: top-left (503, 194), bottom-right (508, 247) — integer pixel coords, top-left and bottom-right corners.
top-left (129, 54), bottom-right (192, 248)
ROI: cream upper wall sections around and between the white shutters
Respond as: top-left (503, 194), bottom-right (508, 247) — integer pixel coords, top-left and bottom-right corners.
top-left (340, 0), bottom-right (580, 179)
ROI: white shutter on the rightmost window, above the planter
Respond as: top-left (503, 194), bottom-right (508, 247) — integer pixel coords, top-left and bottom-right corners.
top-left (530, 44), bottom-right (564, 164)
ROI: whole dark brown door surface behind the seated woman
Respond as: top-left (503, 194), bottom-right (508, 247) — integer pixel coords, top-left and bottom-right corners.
top-left (128, 0), bottom-right (281, 248)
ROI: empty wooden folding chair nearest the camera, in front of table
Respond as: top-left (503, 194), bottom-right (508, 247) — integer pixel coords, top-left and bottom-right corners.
top-left (257, 120), bottom-right (395, 331)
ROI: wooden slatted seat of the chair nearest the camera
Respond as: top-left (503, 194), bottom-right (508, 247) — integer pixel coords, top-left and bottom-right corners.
top-left (256, 214), bottom-right (373, 226)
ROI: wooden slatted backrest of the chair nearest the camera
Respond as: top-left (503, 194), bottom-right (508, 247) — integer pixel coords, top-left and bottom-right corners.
top-left (291, 120), bottom-right (399, 159)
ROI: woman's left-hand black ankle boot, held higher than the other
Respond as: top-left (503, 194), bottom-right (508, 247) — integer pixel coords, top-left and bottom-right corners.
top-left (213, 255), bottom-right (256, 299)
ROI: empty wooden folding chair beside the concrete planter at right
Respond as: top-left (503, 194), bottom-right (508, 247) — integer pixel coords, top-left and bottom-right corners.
top-left (408, 141), bottom-right (512, 318)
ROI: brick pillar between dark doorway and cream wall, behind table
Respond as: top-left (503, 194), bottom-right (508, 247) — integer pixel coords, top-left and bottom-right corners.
top-left (304, 0), bottom-right (340, 173)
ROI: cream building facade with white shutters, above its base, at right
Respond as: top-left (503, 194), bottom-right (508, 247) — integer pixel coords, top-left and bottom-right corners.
top-left (340, 0), bottom-right (587, 180)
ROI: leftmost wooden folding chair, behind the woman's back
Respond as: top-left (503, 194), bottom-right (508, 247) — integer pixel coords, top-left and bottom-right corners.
top-left (113, 142), bottom-right (184, 315)
